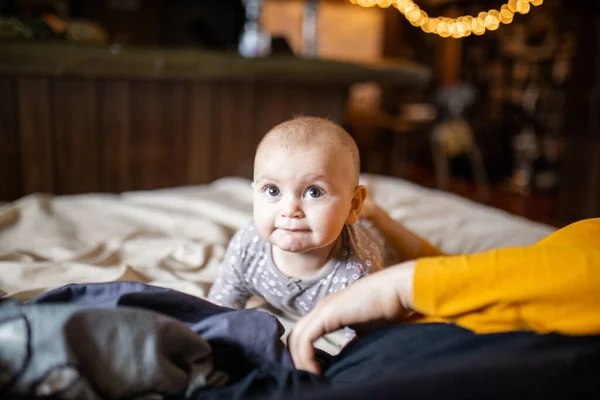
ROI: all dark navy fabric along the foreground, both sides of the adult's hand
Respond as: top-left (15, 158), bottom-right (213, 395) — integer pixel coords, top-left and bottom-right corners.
top-left (21, 282), bottom-right (600, 399)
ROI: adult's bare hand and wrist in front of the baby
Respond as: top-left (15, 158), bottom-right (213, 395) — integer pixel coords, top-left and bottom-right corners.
top-left (288, 261), bottom-right (416, 375)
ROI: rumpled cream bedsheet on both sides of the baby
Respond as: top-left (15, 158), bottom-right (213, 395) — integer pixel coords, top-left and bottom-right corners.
top-left (0, 175), bottom-right (553, 352)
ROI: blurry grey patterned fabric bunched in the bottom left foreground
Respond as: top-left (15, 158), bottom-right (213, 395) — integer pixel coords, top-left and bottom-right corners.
top-left (0, 300), bottom-right (227, 399)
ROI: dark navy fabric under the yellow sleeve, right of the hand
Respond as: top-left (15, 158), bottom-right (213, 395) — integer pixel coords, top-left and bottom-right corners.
top-left (310, 324), bottom-right (600, 399)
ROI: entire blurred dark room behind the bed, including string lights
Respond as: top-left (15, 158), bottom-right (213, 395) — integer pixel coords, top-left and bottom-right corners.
top-left (0, 0), bottom-right (600, 226)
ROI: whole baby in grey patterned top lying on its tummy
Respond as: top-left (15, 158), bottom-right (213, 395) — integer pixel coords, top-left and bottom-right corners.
top-left (209, 117), bottom-right (395, 316)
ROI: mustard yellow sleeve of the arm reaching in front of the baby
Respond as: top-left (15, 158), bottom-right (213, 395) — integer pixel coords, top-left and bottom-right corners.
top-left (413, 220), bottom-right (600, 335)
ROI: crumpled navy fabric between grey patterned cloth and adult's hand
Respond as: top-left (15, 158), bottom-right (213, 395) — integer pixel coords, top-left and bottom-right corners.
top-left (31, 282), bottom-right (320, 399)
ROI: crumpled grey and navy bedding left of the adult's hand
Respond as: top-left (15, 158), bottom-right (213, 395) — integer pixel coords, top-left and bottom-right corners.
top-left (0, 282), bottom-right (314, 399)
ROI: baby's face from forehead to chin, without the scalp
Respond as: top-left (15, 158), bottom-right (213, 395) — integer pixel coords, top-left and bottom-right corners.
top-left (254, 146), bottom-right (356, 252)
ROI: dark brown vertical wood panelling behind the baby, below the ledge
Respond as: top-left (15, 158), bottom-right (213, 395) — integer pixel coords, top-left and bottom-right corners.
top-left (0, 75), bottom-right (347, 201)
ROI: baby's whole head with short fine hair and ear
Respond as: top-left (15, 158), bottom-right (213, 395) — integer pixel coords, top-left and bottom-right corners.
top-left (254, 117), bottom-right (366, 252)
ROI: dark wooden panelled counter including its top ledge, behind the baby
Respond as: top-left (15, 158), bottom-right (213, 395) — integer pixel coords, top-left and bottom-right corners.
top-left (0, 44), bottom-right (429, 200)
